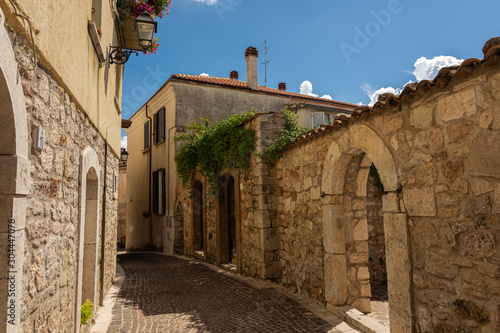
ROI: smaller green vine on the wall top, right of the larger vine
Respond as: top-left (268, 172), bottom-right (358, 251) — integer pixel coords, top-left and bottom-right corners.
top-left (259, 110), bottom-right (309, 163)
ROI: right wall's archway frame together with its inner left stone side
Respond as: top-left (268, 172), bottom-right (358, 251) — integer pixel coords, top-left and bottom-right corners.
top-left (322, 124), bottom-right (413, 332)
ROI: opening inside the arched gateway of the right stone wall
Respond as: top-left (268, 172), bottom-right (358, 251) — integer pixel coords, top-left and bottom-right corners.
top-left (343, 151), bottom-right (390, 327)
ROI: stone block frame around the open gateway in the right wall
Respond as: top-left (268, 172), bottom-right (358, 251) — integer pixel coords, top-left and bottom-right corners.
top-left (321, 124), bottom-right (413, 332)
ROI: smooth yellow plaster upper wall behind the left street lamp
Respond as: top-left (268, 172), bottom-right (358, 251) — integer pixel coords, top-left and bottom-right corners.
top-left (0, 0), bottom-right (123, 154)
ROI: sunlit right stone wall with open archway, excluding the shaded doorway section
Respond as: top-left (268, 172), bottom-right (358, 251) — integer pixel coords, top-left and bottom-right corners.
top-left (276, 50), bottom-right (500, 332)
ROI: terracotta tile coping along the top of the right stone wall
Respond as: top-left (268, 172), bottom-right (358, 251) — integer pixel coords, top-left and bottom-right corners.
top-left (289, 37), bottom-right (500, 146)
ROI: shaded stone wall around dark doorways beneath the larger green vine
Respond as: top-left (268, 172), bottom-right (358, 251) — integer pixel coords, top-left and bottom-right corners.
top-left (176, 112), bottom-right (284, 278)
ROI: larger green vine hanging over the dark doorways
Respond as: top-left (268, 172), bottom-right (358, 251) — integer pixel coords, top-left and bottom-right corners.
top-left (174, 111), bottom-right (256, 193)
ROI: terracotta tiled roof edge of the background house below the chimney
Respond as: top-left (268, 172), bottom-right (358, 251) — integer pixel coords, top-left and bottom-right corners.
top-left (170, 74), bottom-right (358, 107)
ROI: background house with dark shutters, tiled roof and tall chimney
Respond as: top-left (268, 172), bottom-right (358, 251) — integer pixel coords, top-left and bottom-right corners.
top-left (125, 47), bottom-right (357, 254)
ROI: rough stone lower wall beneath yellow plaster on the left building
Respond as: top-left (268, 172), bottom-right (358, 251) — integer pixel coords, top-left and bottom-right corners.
top-left (11, 25), bottom-right (118, 332)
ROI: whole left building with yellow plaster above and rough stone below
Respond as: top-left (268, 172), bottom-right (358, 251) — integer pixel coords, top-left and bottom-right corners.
top-left (0, 0), bottom-right (145, 332)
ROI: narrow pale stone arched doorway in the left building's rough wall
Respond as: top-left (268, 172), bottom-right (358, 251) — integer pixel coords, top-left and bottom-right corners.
top-left (75, 147), bottom-right (100, 332)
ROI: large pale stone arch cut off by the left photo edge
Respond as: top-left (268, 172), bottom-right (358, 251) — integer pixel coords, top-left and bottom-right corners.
top-left (0, 9), bottom-right (30, 332)
